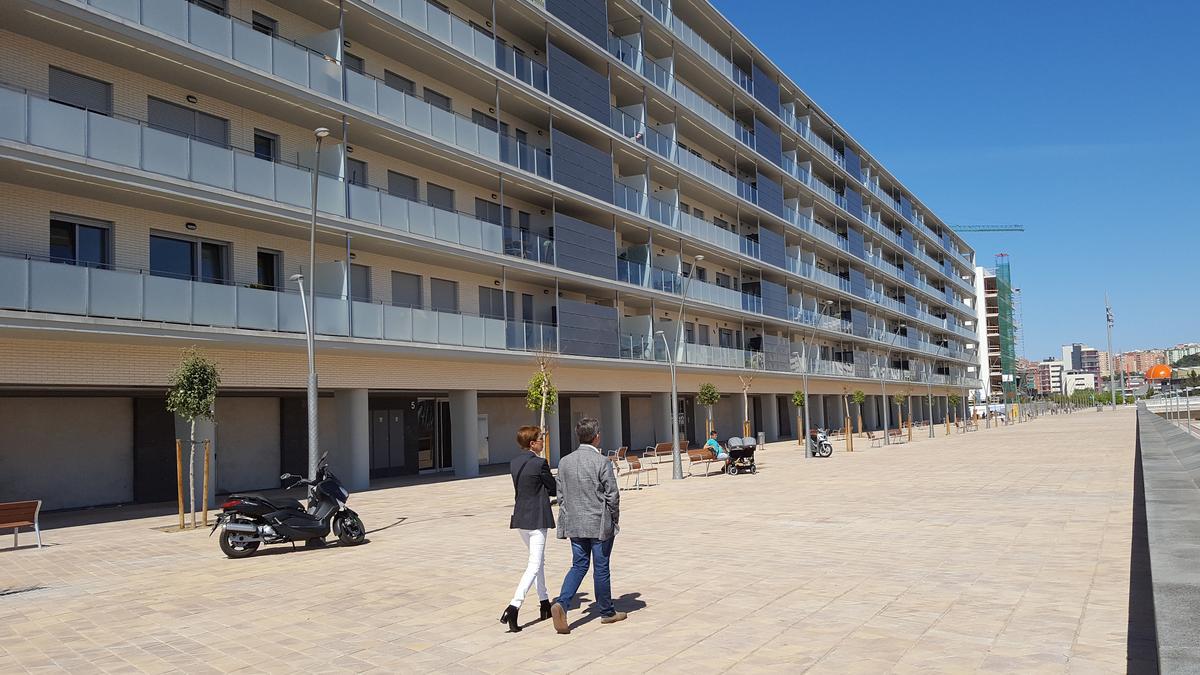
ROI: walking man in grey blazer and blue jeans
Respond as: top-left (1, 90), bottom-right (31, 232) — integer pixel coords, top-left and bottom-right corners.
top-left (550, 417), bottom-right (625, 635)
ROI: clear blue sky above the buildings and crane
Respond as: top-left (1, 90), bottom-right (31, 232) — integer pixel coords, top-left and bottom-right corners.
top-left (714, 0), bottom-right (1200, 360)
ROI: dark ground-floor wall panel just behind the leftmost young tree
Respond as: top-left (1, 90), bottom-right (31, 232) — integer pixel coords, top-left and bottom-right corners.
top-left (133, 398), bottom-right (177, 502)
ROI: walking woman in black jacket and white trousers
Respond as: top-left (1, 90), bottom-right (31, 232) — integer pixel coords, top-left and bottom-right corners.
top-left (500, 426), bottom-right (556, 633)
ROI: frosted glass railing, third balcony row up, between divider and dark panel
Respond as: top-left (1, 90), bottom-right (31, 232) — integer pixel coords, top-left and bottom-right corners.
top-left (346, 71), bottom-right (551, 179)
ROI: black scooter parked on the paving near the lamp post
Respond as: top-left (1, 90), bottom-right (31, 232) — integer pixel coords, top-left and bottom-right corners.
top-left (209, 453), bottom-right (366, 557)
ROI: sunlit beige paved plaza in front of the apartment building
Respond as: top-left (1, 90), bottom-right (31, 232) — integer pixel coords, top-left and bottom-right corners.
top-left (0, 408), bottom-right (1146, 675)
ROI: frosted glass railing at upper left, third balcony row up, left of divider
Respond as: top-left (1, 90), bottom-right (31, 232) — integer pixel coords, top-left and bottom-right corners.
top-left (88, 0), bottom-right (342, 98)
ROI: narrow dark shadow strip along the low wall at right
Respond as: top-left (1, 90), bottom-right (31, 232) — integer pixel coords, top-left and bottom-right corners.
top-left (1126, 420), bottom-right (1158, 674)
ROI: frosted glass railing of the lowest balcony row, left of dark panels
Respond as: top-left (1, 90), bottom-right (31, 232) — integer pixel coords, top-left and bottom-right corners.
top-left (0, 256), bottom-right (571, 351)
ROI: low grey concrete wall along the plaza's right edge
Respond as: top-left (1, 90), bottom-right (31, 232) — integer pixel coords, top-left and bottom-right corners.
top-left (1138, 406), bottom-right (1200, 673)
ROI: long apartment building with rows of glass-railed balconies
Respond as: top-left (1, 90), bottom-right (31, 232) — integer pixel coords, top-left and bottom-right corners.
top-left (0, 0), bottom-right (979, 508)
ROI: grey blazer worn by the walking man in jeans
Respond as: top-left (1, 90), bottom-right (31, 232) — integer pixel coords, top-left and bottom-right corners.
top-left (556, 446), bottom-right (620, 539)
